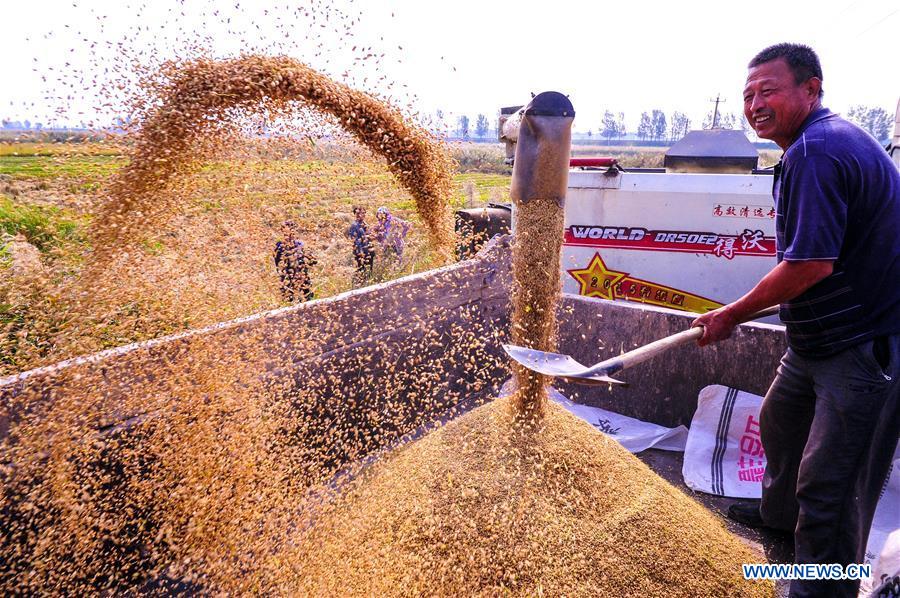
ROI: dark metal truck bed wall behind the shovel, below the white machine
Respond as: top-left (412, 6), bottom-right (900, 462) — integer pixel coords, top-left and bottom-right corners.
top-left (555, 295), bottom-right (787, 427)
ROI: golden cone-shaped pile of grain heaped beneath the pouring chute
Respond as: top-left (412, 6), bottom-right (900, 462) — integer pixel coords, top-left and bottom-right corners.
top-left (279, 399), bottom-right (772, 598)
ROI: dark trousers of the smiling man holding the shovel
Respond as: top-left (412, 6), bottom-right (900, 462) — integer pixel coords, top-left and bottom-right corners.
top-left (760, 335), bottom-right (900, 598)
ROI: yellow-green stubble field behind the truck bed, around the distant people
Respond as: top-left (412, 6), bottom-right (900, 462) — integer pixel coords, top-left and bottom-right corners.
top-left (0, 142), bottom-right (510, 375)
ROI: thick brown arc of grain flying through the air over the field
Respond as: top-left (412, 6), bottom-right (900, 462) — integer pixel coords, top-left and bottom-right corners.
top-left (93, 55), bottom-right (453, 262)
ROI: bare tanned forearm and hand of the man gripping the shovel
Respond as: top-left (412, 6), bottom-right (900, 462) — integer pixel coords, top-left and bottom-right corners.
top-left (691, 260), bottom-right (834, 347)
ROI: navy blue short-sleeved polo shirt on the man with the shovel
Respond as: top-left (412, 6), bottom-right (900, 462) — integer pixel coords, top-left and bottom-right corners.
top-left (773, 108), bottom-right (900, 357)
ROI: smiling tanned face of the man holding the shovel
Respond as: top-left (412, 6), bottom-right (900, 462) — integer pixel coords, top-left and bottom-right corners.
top-left (744, 58), bottom-right (822, 149)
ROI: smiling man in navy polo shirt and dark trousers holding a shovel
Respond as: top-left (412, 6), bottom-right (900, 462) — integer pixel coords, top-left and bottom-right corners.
top-left (694, 44), bottom-right (900, 597)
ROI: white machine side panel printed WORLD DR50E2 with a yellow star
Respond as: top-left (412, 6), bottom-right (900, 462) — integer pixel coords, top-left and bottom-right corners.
top-left (561, 170), bottom-right (775, 312)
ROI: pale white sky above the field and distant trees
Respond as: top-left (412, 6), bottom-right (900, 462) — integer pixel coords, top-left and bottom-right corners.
top-left (0, 0), bottom-right (900, 132)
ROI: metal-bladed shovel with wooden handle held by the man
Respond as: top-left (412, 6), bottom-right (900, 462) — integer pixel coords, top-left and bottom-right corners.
top-left (503, 305), bottom-right (778, 385)
